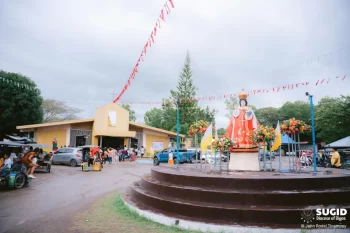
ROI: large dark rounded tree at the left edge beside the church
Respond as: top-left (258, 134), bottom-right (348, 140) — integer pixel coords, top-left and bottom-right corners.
top-left (0, 70), bottom-right (43, 139)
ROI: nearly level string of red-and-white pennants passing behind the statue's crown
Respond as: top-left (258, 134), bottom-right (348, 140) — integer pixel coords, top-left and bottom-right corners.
top-left (120, 75), bottom-right (346, 105)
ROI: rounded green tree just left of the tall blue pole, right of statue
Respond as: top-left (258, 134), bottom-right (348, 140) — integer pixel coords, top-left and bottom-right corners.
top-left (279, 100), bottom-right (311, 124)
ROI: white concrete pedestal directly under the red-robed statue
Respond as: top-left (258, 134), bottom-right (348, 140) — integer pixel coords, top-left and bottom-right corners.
top-left (229, 152), bottom-right (260, 171)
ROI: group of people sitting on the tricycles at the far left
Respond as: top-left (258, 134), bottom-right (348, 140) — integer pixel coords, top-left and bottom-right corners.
top-left (0, 147), bottom-right (52, 179)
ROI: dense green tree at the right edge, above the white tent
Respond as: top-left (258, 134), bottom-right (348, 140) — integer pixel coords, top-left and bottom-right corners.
top-left (315, 96), bottom-right (350, 143)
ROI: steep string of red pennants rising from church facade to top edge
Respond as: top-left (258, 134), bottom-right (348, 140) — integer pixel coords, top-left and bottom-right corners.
top-left (113, 0), bottom-right (175, 103)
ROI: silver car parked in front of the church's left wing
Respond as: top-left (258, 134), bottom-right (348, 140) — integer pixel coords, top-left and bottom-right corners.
top-left (52, 147), bottom-right (83, 167)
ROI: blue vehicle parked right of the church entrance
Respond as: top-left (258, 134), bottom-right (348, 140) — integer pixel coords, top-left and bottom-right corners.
top-left (153, 148), bottom-right (196, 166)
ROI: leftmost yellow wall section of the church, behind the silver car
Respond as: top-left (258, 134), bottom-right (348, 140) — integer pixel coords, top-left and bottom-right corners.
top-left (35, 129), bottom-right (67, 149)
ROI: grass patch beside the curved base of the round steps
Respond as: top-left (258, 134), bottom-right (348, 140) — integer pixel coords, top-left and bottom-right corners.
top-left (70, 194), bottom-right (199, 233)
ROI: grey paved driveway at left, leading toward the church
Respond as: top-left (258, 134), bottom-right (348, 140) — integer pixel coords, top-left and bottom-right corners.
top-left (0, 162), bottom-right (152, 233)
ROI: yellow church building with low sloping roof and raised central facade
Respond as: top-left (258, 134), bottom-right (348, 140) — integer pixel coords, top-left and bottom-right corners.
top-left (17, 103), bottom-right (184, 151)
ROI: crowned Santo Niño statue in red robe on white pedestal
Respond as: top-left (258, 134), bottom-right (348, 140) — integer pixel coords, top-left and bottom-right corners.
top-left (226, 90), bottom-right (259, 148)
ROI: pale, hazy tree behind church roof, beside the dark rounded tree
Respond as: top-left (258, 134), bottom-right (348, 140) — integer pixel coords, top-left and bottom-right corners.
top-left (42, 99), bottom-right (81, 122)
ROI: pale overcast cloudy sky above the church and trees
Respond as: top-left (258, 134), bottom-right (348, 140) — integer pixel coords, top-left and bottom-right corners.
top-left (0, 0), bottom-right (350, 128)
